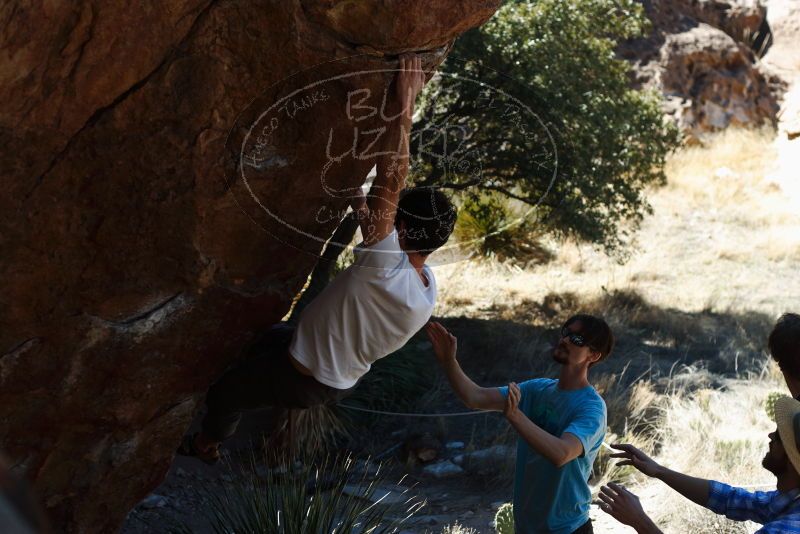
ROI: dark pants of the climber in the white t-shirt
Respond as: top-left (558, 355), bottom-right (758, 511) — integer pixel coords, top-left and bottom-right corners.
top-left (202, 323), bottom-right (353, 441)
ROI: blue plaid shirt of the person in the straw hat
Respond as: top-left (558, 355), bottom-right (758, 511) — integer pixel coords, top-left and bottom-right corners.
top-left (706, 480), bottom-right (800, 534)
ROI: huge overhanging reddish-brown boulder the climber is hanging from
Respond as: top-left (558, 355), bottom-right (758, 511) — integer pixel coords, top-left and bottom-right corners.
top-left (0, 0), bottom-right (499, 532)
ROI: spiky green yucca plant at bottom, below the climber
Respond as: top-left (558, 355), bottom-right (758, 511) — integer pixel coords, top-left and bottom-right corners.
top-left (171, 453), bottom-right (424, 534)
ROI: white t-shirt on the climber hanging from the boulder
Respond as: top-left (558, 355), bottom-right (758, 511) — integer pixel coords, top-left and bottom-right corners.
top-left (289, 231), bottom-right (436, 389)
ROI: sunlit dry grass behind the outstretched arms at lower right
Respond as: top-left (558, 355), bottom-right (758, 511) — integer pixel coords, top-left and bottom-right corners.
top-left (592, 364), bottom-right (786, 534)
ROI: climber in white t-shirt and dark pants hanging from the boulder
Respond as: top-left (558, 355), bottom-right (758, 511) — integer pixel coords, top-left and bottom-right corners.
top-left (178, 54), bottom-right (456, 463)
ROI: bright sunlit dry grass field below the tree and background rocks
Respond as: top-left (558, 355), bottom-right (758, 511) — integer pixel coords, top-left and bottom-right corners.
top-left (435, 130), bottom-right (800, 317)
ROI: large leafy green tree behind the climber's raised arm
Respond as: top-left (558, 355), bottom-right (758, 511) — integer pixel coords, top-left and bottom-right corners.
top-left (412, 0), bottom-right (679, 254)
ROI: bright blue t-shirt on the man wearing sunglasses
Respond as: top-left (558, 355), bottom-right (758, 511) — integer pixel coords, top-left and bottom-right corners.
top-left (498, 378), bottom-right (606, 534)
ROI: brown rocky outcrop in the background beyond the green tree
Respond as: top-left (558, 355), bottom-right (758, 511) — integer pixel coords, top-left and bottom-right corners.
top-left (620, 0), bottom-right (798, 140)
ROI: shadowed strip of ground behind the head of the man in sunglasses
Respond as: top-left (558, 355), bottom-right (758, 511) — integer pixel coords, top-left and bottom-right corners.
top-left (443, 291), bottom-right (775, 390)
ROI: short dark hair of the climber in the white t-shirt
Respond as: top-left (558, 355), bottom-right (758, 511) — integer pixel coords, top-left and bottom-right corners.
top-left (394, 186), bottom-right (456, 255)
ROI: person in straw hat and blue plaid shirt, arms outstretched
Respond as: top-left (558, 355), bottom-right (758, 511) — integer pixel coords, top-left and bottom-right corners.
top-left (599, 397), bottom-right (800, 534)
